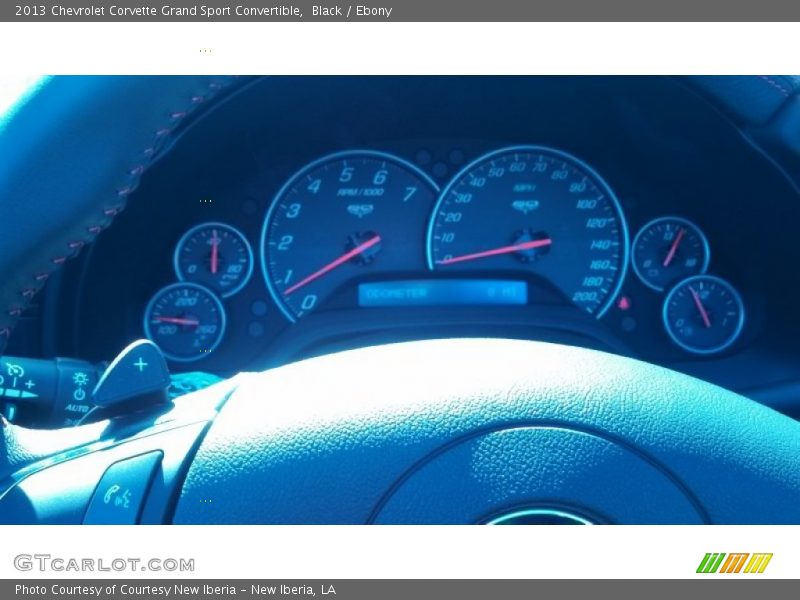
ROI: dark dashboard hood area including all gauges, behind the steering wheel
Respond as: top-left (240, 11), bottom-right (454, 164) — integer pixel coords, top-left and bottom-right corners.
top-left (17, 77), bottom-right (800, 412)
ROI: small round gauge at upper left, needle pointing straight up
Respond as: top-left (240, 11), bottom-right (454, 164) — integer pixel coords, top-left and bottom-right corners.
top-left (173, 223), bottom-right (253, 298)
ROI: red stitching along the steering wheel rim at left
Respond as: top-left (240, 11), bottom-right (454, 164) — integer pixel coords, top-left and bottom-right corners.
top-left (0, 78), bottom-right (235, 350)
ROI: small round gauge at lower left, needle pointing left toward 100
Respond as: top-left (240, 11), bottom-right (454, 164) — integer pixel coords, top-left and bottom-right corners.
top-left (144, 283), bottom-right (225, 362)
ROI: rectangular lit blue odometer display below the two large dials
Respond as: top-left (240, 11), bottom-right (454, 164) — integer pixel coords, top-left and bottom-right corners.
top-left (358, 279), bottom-right (528, 307)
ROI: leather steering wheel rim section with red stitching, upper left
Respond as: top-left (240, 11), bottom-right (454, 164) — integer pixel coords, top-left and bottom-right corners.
top-left (0, 76), bottom-right (235, 352)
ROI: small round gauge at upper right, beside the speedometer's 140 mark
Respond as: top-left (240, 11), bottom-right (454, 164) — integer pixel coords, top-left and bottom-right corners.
top-left (631, 217), bottom-right (711, 292)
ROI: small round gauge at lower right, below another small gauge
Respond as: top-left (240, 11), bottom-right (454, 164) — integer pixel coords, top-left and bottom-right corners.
top-left (663, 275), bottom-right (744, 354)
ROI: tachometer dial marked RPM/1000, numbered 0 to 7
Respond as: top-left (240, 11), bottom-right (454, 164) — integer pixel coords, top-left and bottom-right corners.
top-left (261, 151), bottom-right (438, 321)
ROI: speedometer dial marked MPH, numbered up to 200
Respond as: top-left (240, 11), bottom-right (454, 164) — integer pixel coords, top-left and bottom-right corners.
top-left (428, 146), bottom-right (628, 317)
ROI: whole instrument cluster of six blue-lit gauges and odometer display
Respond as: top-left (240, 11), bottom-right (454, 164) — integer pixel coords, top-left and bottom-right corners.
top-left (142, 145), bottom-right (747, 363)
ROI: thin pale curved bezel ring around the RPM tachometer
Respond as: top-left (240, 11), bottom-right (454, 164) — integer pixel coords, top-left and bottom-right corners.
top-left (258, 149), bottom-right (440, 323)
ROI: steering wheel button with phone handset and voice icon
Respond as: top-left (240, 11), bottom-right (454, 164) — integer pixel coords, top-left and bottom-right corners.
top-left (83, 452), bottom-right (162, 525)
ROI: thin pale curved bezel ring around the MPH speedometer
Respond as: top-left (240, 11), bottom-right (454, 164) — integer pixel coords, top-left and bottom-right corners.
top-left (425, 144), bottom-right (630, 319)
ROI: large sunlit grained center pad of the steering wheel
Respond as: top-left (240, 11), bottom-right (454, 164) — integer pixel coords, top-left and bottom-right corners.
top-left (174, 339), bottom-right (800, 523)
